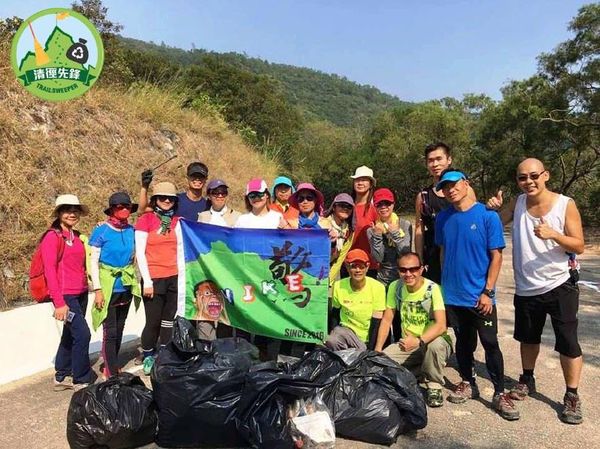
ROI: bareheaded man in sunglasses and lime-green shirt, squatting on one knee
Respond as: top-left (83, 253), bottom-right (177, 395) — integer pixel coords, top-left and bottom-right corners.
top-left (375, 252), bottom-right (452, 407)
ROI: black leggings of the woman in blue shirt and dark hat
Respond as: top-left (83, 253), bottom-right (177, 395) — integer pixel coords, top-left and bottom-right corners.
top-left (102, 291), bottom-right (131, 377)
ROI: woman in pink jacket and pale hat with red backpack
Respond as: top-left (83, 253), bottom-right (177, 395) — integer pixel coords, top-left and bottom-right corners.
top-left (40, 195), bottom-right (92, 391)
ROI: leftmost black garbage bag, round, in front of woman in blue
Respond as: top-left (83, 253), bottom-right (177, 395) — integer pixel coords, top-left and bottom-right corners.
top-left (67, 373), bottom-right (157, 449)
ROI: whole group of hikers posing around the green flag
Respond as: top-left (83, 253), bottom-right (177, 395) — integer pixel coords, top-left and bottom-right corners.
top-left (41, 143), bottom-right (584, 424)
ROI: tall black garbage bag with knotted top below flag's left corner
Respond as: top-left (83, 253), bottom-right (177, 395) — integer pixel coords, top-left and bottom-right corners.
top-left (151, 318), bottom-right (258, 447)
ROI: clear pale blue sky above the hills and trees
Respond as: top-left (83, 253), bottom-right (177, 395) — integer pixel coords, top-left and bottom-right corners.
top-left (0, 0), bottom-right (590, 101)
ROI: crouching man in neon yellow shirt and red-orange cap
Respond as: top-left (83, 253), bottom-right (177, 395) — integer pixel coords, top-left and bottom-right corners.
top-left (325, 249), bottom-right (385, 351)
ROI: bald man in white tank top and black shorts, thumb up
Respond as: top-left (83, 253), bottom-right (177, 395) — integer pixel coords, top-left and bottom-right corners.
top-left (487, 158), bottom-right (584, 424)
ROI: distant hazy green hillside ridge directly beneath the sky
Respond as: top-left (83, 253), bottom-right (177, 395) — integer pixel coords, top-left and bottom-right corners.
top-left (122, 38), bottom-right (406, 126)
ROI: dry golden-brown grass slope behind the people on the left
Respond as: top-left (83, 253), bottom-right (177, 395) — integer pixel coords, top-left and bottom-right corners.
top-left (0, 42), bottom-right (277, 309)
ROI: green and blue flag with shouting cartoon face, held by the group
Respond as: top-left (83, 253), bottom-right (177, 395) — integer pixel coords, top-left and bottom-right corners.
top-left (177, 220), bottom-right (330, 343)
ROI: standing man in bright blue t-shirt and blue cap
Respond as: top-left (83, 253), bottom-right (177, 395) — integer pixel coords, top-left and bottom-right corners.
top-left (435, 169), bottom-right (519, 420)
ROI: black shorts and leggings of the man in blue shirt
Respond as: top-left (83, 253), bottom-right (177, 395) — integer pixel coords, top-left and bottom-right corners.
top-left (447, 306), bottom-right (504, 393)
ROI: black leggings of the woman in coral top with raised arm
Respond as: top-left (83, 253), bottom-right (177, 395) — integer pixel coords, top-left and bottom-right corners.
top-left (142, 276), bottom-right (177, 354)
